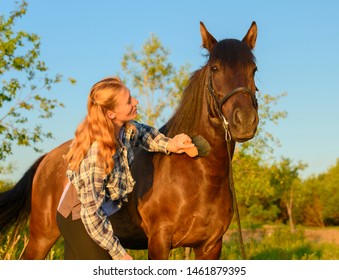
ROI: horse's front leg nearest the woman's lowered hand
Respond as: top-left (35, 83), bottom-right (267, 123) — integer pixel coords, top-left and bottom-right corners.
top-left (148, 227), bottom-right (171, 260)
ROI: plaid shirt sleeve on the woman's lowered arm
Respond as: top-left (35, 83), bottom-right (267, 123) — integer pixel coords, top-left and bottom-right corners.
top-left (70, 151), bottom-right (126, 259)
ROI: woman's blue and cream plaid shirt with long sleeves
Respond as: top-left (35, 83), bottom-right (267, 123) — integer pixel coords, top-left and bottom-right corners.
top-left (67, 121), bottom-right (169, 259)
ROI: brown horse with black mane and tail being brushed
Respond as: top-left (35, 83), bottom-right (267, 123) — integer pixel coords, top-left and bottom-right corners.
top-left (0, 21), bottom-right (259, 259)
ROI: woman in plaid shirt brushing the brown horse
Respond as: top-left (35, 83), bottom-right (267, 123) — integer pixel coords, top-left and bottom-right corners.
top-left (57, 78), bottom-right (194, 259)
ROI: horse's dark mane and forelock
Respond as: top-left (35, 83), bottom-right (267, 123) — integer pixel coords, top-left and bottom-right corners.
top-left (161, 39), bottom-right (255, 137)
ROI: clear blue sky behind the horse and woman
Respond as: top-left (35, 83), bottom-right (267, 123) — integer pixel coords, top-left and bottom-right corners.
top-left (0, 0), bottom-right (339, 180)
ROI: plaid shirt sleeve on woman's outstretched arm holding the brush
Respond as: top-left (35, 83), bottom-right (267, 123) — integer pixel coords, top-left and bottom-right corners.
top-left (133, 121), bottom-right (170, 154)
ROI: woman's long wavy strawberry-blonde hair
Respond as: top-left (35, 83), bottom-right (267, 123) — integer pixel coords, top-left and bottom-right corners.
top-left (65, 77), bottom-right (125, 175)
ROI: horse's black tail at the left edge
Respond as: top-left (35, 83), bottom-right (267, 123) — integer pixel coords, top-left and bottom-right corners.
top-left (0, 155), bottom-right (45, 237)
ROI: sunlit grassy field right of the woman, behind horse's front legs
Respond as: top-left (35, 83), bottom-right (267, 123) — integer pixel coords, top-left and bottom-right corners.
top-left (130, 226), bottom-right (339, 260)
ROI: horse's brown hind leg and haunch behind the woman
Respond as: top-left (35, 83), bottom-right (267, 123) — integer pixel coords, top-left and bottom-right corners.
top-left (22, 148), bottom-right (67, 259)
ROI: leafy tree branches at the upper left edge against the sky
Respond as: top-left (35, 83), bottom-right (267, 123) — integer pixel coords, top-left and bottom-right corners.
top-left (0, 1), bottom-right (75, 164)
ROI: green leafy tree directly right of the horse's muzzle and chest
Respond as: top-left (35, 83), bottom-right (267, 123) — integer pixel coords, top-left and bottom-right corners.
top-left (232, 92), bottom-right (287, 223)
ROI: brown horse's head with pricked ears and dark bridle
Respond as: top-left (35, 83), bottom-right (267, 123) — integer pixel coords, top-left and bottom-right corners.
top-left (200, 22), bottom-right (259, 142)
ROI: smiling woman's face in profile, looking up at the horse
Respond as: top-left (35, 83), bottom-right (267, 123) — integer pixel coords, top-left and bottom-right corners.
top-left (111, 87), bottom-right (139, 124)
